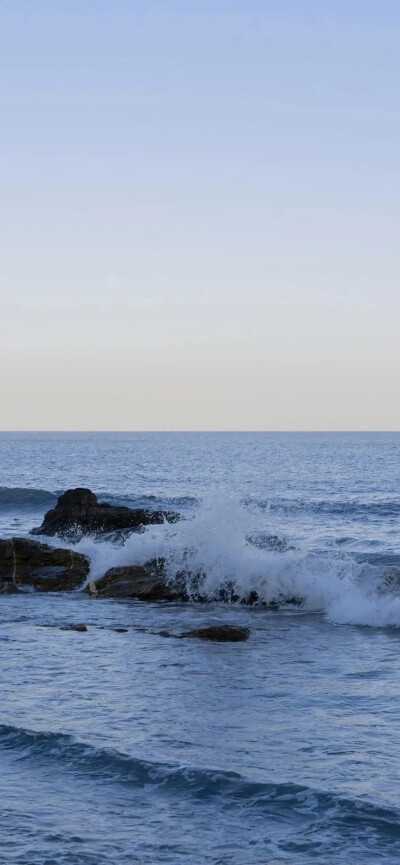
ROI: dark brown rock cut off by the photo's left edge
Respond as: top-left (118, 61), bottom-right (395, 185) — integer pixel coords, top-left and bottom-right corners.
top-left (0, 538), bottom-right (89, 592)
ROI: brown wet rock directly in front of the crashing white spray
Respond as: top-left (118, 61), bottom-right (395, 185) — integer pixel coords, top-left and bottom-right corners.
top-left (87, 565), bottom-right (182, 601)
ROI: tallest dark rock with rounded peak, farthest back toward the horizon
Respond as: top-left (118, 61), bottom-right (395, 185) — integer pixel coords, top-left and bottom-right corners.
top-left (31, 488), bottom-right (179, 538)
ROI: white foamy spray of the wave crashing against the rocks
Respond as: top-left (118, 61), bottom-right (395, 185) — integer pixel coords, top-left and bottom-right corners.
top-left (77, 494), bottom-right (400, 627)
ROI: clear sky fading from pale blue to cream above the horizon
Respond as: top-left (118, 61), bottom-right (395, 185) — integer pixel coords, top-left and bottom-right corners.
top-left (0, 0), bottom-right (400, 430)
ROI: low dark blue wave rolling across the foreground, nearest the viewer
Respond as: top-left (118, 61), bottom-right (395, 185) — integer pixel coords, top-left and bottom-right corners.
top-left (0, 724), bottom-right (400, 841)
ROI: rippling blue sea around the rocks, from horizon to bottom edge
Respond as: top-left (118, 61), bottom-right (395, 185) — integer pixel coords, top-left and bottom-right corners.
top-left (0, 433), bottom-right (400, 865)
